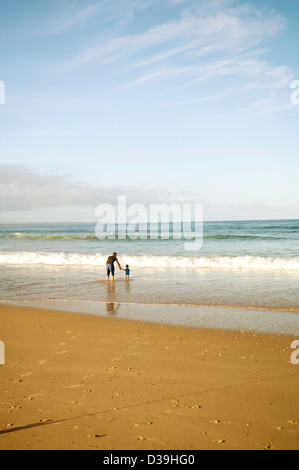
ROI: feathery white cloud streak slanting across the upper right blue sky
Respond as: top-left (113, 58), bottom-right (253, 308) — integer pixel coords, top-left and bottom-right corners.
top-left (67, 2), bottom-right (286, 66)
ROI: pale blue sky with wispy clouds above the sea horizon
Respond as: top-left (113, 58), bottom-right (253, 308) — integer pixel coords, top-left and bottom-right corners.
top-left (0, 0), bottom-right (299, 223)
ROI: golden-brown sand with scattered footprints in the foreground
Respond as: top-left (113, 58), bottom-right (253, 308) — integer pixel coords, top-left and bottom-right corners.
top-left (0, 305), bottom-right (299, 450)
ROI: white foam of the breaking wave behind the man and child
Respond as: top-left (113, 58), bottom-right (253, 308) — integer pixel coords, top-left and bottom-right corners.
top-left (0, 252), bottom-right (299, 271)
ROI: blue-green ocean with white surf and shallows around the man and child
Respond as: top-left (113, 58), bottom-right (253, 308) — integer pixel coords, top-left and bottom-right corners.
top-left (0, 220), bottom-right (299, 334)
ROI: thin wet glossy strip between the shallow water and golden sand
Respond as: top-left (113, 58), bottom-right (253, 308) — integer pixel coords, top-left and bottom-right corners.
top-left (0, 297), bottom-right (299, 335)
